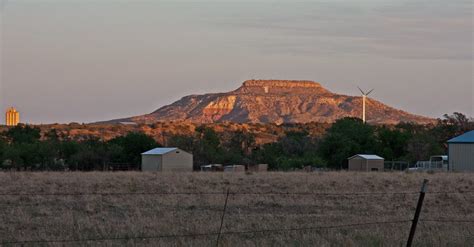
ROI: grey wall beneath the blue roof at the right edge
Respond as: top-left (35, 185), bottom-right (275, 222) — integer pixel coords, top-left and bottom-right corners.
top-left (449, 143), bottom-right (474, 172)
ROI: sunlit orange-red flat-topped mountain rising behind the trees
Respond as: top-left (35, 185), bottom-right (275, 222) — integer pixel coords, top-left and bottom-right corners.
top-left (114, 80), bottom-right (433, 124)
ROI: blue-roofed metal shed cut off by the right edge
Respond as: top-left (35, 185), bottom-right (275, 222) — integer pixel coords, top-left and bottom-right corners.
top-left (448, 130), bottom-right (474, 172)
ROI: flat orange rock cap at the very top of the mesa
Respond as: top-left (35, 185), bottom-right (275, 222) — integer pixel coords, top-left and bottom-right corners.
top-left (235, 80), bottom-right (329, 94)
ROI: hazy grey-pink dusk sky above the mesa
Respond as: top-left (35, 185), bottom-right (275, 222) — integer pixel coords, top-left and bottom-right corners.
top-left (0, 0), bottom-right (474, 123)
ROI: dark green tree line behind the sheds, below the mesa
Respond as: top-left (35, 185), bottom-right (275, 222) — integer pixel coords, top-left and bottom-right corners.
top-left (0, 113), bottom-right (474, 171)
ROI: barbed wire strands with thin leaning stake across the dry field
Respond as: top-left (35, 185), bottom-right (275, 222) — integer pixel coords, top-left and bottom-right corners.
top-left (0, 181), bottom-right (474, 246)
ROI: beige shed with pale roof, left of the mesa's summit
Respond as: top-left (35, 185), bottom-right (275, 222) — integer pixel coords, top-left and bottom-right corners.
top-left (142, 148), bottom-right (193, 172)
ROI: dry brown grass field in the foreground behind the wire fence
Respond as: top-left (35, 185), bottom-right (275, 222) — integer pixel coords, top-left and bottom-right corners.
top-left (0, 172), bottom-right (474, 246)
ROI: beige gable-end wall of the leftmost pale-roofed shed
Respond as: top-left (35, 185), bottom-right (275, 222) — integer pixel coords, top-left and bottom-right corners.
top-left (162, 150), bottom-right (193, 172)
